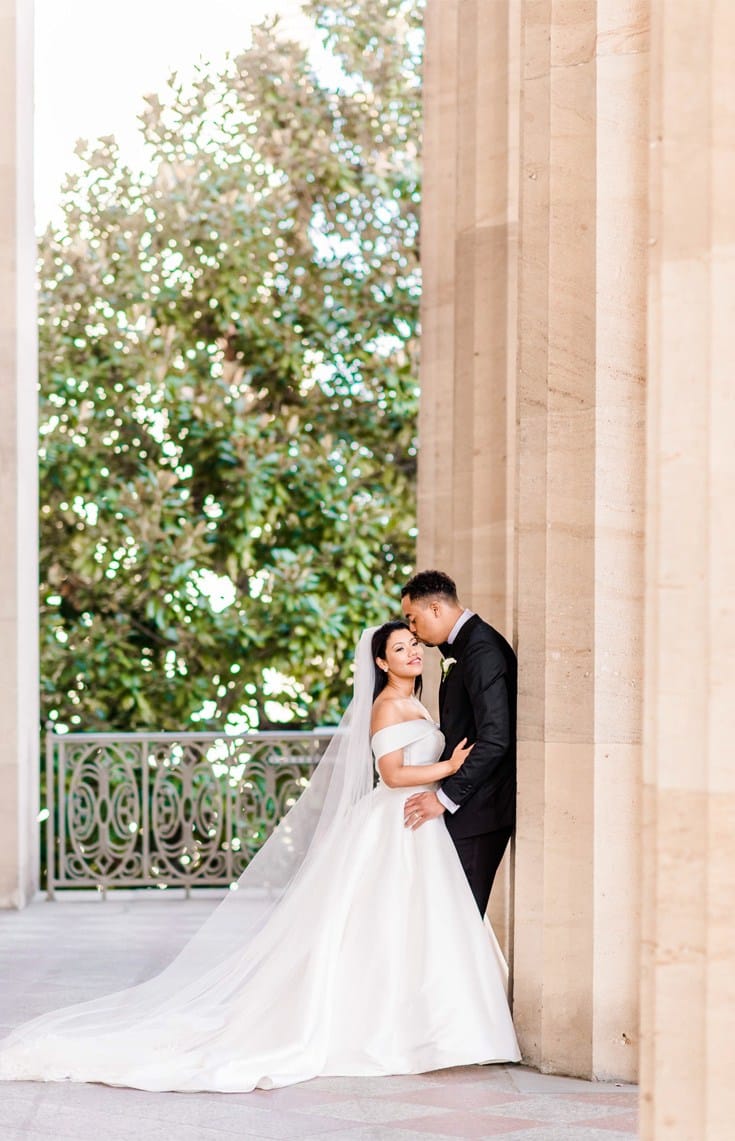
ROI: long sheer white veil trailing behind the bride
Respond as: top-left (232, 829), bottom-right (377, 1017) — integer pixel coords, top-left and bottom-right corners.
top-left (0, 628), bottom-right (377, 1063)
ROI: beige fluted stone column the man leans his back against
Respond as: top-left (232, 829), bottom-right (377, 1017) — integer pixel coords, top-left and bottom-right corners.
top-left (514, 0), bottom-right (647, 1078)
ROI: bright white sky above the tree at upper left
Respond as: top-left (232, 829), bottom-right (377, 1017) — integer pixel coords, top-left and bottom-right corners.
top-left (35, 0), bottom-right (314, 227)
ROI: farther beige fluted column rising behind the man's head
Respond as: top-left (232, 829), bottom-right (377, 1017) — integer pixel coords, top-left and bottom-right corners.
top-left (418, 0), bottom-right (519, 953)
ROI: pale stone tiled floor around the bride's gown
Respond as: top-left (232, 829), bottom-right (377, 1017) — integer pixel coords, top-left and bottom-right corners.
top-left (0, 895), bottom-right (637, 1141)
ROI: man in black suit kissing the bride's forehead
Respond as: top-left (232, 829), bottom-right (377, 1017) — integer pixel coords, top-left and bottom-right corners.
top-left (401, 571), bottom-right (518, 915)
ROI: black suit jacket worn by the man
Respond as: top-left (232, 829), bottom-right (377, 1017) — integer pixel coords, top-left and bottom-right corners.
top-left (439, 614), bottom-right (518, 839)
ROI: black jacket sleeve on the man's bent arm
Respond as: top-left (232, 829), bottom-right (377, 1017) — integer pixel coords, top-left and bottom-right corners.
top-left (442, 641), bottom-right (510, 808)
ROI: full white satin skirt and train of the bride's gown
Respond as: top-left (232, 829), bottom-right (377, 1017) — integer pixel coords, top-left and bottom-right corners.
top-left (0, 785), bottom-right (520, 1092)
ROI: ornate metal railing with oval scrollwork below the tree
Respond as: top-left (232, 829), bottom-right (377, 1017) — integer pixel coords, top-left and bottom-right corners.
top-left (46, 729), bottom-right (332, 898)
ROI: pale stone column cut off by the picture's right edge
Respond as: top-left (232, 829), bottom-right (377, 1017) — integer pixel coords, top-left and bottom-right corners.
top-left (641, 2), bottom-right (735, 1141)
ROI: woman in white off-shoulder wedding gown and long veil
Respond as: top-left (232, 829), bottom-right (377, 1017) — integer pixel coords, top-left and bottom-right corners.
top-left (0, 622), bottom-right (520, 1092)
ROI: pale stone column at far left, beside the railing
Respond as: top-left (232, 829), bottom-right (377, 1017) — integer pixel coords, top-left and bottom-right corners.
top-left (0, 0), bottom-right (39, 907)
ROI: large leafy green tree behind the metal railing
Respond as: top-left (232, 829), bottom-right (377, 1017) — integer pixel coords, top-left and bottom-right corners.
top-left (40, 0), bottom-right (421, 729)
